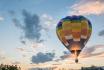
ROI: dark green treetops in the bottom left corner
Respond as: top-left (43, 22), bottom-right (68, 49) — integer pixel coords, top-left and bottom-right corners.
top-left (0, 64), bottom-right (21, 70)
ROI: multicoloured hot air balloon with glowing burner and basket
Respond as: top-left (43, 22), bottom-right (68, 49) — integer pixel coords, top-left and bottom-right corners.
top-left (56, 15), bottom-right (92, 63)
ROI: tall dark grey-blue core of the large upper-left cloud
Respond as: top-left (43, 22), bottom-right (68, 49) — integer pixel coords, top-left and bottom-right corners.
top-left (22, 10), bottom-right (42, 42)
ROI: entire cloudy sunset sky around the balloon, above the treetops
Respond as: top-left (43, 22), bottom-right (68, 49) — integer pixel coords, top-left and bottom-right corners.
top-left (0, 0), bottom-right (104, 69)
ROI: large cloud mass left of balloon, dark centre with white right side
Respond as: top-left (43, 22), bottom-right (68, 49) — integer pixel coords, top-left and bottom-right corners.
top-left (8, 10), bottom-right (55, 45)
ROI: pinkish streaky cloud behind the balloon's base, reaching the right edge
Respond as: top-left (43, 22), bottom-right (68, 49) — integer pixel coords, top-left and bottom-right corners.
top-left (60, 45), bottom-right (104, 59)
